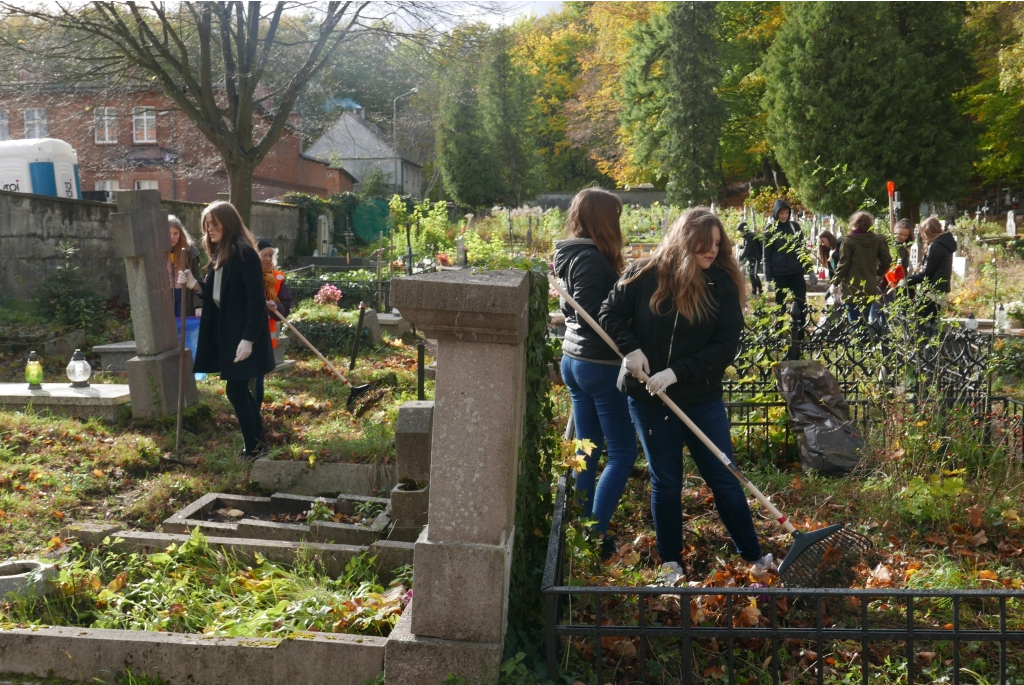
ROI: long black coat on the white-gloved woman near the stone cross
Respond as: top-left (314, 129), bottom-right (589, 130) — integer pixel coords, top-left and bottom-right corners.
top-left (193, 239), bottom-right (274, 381)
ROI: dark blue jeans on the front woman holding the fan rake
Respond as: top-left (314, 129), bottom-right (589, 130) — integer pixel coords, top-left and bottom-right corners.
top-left (630, 397), bottom-right (761, 563)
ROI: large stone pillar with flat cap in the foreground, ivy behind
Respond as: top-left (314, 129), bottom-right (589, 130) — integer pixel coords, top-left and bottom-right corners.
top-left (385, 269), bottom-right (529, 685)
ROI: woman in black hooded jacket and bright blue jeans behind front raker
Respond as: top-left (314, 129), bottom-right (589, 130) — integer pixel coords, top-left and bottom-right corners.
top-left (554, 188), bottom-right (637, 556)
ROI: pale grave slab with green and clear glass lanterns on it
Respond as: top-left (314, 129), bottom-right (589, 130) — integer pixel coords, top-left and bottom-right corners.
top-left (0, 383), bottom-right (131, 422)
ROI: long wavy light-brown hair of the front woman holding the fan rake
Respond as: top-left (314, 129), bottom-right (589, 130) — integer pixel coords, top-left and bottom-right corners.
top-left (626, 207), bottom-right (746, 323)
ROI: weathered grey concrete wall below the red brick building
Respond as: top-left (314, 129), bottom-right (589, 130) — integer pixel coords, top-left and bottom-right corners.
top-left (0, 191), bottom-right (304, 303)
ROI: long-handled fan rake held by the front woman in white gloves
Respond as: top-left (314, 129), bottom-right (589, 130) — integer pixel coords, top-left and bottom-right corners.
top-left (548, 274), bottom-right (872, 588)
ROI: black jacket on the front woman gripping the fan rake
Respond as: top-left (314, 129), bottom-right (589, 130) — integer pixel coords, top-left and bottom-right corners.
top-left (598, 260), bottom-right (743, 405)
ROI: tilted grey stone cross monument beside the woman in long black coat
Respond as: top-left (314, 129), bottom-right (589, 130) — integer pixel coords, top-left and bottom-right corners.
top-left (111, 190), bottom-right (198, 419)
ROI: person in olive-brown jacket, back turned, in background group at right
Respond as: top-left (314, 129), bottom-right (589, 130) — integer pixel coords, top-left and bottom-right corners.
top-left (835, 212), bottom-right (893, 326)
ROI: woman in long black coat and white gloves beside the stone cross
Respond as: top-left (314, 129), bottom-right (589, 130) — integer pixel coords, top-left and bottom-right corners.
top-left (178, 202), bottom-right (273, 461)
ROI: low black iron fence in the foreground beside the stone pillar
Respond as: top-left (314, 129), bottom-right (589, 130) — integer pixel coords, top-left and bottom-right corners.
top-left (542, 477), bottom-right (1024, 685)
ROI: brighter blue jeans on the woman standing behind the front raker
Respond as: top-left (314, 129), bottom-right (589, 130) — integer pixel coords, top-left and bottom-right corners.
top-left (562, 354), bottom-right (637, 533)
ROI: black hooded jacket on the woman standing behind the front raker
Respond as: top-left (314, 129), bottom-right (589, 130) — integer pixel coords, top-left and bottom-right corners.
top-left (554, 238), bottom-right (618, 365)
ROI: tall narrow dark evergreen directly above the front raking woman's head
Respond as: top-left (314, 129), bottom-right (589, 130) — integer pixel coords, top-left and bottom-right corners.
top-left (664, 1), bottom-right (726, 205)
